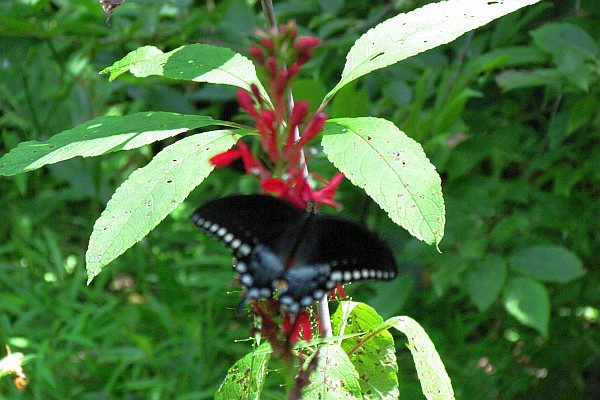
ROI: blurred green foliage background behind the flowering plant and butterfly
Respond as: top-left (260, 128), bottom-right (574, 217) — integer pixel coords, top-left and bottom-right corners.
top-left (0, 0), bottom-right (600, 400)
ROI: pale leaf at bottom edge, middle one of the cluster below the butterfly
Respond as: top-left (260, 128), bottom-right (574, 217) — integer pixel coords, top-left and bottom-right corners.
top-left (302, 344), bottom-right (363, 400)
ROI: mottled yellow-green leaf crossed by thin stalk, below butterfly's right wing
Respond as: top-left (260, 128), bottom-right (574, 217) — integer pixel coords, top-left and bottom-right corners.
top-left (332, 301), bottom-right (399, 399)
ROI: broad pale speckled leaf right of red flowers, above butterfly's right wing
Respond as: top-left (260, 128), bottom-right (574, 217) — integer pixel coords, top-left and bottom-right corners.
top-left (322, 117), bottom-right (445, 245)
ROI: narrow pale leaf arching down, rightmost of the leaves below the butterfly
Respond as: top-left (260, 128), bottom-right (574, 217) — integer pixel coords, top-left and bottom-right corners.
top-left (385, 317), bottom-right (454, 400)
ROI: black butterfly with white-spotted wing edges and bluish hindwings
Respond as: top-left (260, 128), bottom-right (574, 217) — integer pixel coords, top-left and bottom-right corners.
top-left (192, 195), bottom-right (397, 315)
